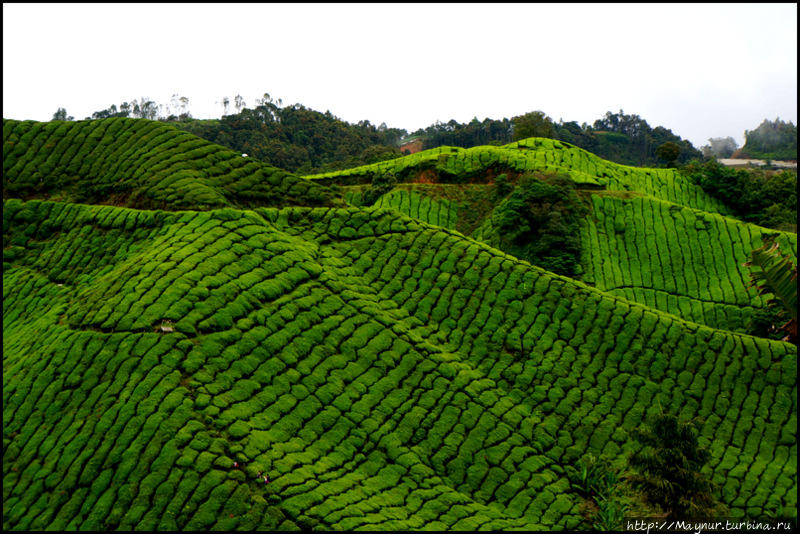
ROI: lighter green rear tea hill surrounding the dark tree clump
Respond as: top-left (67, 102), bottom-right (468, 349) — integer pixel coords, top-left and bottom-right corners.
top-left (310, 139), bottom-right (797, 332)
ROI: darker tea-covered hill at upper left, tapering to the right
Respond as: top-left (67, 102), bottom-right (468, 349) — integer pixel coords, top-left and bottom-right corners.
top-left (3, 118), bottom-right (337, 209)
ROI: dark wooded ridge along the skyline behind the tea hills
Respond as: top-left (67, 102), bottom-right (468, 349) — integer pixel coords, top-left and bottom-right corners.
top-left (53, 98), bottom-right (703, 174)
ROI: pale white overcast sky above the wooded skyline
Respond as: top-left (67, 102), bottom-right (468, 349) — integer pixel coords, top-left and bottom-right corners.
top-left (3, 3), bottom-right (797, 147)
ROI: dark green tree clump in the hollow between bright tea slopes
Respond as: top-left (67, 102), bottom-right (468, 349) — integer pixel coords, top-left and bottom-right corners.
top-left (492, 175), bottom-right (586, 276)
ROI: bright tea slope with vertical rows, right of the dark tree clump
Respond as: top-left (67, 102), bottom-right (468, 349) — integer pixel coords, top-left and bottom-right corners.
top-left (582, 195), bottom-right (797, 332)
